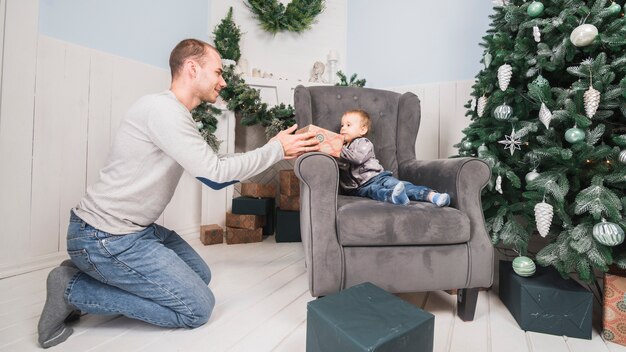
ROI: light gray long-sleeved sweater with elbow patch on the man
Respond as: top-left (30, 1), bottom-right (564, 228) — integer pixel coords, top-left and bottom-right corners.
top-left (74, 90), bottom-right (284, 235)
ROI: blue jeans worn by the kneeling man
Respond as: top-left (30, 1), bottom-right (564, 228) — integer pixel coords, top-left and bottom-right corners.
top-left (65, 212), bottom-right (215, 328)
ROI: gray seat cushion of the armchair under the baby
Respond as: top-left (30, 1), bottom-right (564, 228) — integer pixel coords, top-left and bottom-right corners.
top-left (337, 196), bottom-right (470, 246)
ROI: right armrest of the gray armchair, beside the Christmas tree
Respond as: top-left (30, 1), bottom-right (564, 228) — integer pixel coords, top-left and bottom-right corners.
top-left (398, 158), bottom-right (494, 288)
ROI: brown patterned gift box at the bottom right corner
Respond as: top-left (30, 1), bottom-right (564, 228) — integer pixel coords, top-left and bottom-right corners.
top-left (602, 274), bottom-right (626, 345)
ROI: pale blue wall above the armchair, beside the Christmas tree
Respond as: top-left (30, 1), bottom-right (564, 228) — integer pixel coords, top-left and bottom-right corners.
top-left (346, 0), bottom-right (493, 88)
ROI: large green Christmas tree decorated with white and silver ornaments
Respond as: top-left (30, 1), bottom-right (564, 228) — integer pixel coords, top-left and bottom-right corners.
top-left (456, 0), bottom-right (626, 282)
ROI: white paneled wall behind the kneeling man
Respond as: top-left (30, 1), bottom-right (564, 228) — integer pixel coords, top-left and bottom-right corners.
top-left (0, 31), bottom-right (214, 277)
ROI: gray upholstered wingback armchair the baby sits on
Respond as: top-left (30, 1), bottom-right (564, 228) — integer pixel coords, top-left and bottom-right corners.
top-left (294, 86), bottom-right (494, 321)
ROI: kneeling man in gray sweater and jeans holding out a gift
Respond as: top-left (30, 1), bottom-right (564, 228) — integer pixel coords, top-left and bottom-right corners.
top-left (38, 39), bottom-right (319, 348)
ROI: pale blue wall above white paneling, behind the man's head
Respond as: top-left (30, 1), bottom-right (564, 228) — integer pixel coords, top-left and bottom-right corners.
top-left (39, 0), bottom-right (211, 68)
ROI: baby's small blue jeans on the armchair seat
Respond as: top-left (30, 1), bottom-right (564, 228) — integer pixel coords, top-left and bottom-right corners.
top-left (356, 171), bottom-right (433, 202)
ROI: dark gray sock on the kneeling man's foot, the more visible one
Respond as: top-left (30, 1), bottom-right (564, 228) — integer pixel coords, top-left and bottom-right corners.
top-left (37, 266), bottom-right (78, 348)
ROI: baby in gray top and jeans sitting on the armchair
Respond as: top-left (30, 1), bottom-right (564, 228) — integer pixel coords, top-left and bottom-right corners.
top-left (338, 110), bottom-right (450, 207)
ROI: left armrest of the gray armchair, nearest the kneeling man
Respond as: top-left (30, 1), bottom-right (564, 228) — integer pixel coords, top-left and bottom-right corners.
top-left (294, 153), bottom-right (344, 297)
